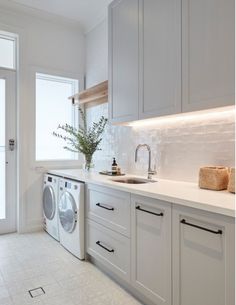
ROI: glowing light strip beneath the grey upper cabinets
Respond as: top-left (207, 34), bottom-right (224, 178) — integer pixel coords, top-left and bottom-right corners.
top-left (127, 106), bottom-right (235, 128)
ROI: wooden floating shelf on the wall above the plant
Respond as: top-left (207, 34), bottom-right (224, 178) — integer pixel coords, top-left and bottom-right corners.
top-left (69, 80), bottom-right (108, 105)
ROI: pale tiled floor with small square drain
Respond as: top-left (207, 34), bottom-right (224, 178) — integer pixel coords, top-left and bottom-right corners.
top-left (0, 232), bottom-right (140, 305)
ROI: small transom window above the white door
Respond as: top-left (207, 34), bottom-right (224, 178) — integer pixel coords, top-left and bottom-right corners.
top-left (0, 33), bottom-right (16, 69)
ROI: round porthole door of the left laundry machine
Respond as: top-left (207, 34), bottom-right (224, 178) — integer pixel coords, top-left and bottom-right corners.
top-left (43, 185), bottom-right (56, 220)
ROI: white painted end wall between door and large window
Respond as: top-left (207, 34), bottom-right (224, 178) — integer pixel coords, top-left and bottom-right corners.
top-left (0, 7), bottom-right (84, 231)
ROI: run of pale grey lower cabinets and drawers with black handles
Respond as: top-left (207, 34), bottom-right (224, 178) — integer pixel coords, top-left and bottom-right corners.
top-left (86, 185), bottom-right (235, 305)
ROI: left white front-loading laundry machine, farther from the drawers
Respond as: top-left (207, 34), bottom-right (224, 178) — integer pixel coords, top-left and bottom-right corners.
top-left (43, 174), bottom-right (59, 241)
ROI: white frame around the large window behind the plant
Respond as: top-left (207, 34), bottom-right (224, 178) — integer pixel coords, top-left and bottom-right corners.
top-left (29, 66), bottom-right (84, 172)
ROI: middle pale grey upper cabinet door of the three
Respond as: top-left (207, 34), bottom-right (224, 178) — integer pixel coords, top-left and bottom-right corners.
top-left (139, 0), bottom-right (181, 119)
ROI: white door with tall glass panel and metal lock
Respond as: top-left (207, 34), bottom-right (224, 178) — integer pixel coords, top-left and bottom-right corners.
top-left (0, 69), bottom-right (16, 234)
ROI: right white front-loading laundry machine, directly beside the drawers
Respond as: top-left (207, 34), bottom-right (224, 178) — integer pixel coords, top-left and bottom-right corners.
top-left (58, 178), bottom-right (84, 259)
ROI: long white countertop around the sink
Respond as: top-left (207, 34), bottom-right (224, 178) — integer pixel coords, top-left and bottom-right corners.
top-left (49, 169), bottom-right (235, 217)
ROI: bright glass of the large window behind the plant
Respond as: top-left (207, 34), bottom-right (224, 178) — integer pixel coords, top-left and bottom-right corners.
top-left (36, 73), bottom-right (79, 161)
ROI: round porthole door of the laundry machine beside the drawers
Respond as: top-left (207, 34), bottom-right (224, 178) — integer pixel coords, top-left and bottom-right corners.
top-left (59, 191), bottom-right (77, 233)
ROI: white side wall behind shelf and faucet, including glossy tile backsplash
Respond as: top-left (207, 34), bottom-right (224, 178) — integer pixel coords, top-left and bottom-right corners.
top-left (86, 21), bottom-right (235, 182)
